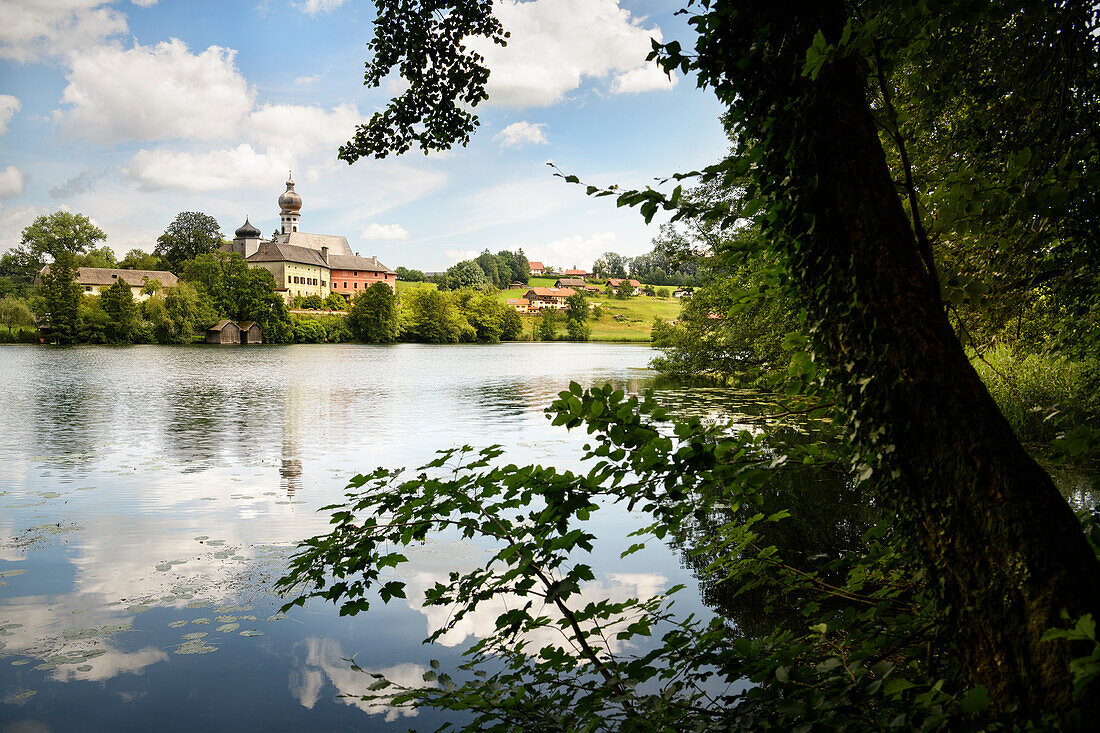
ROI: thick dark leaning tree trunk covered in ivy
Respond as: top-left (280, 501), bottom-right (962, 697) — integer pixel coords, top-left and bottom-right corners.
top-left (727, 0), bottom-right (1100, 719)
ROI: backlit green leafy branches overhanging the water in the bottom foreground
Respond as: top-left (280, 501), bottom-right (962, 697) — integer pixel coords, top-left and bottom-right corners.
top-left (278, 384), bottom-right (1016, 731)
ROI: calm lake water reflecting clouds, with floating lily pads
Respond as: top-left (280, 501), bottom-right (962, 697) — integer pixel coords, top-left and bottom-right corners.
top-left (0, 343), bottom-right (729, 731)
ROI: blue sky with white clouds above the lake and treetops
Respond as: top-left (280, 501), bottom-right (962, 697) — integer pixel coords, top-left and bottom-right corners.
top-left (0, 0), bottom-right (727, 271)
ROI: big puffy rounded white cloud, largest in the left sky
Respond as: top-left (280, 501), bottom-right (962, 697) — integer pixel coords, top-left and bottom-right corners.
top-left (54, 39), bottom-right (254, 144)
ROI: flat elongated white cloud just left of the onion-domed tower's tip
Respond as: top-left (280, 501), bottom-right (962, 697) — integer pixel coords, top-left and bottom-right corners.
top-left (125, 143), bottom-right (294, 192)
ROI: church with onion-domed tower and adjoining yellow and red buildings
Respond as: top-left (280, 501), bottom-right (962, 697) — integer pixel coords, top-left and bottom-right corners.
top-left (222, 176), bottom-right (397, 305)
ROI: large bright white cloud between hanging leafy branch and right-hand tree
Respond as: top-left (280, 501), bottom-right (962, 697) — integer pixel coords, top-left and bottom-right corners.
top-left (469, 0), bottom-right (670, 107)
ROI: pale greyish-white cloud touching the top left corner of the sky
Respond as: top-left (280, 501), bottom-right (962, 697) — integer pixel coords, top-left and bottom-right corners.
top-left (0, 0), bottom-right (127, 64)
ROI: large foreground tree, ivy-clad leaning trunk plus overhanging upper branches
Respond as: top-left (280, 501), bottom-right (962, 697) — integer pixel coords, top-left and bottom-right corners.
top-left (292, 0), bottom-right (1100, 724)
